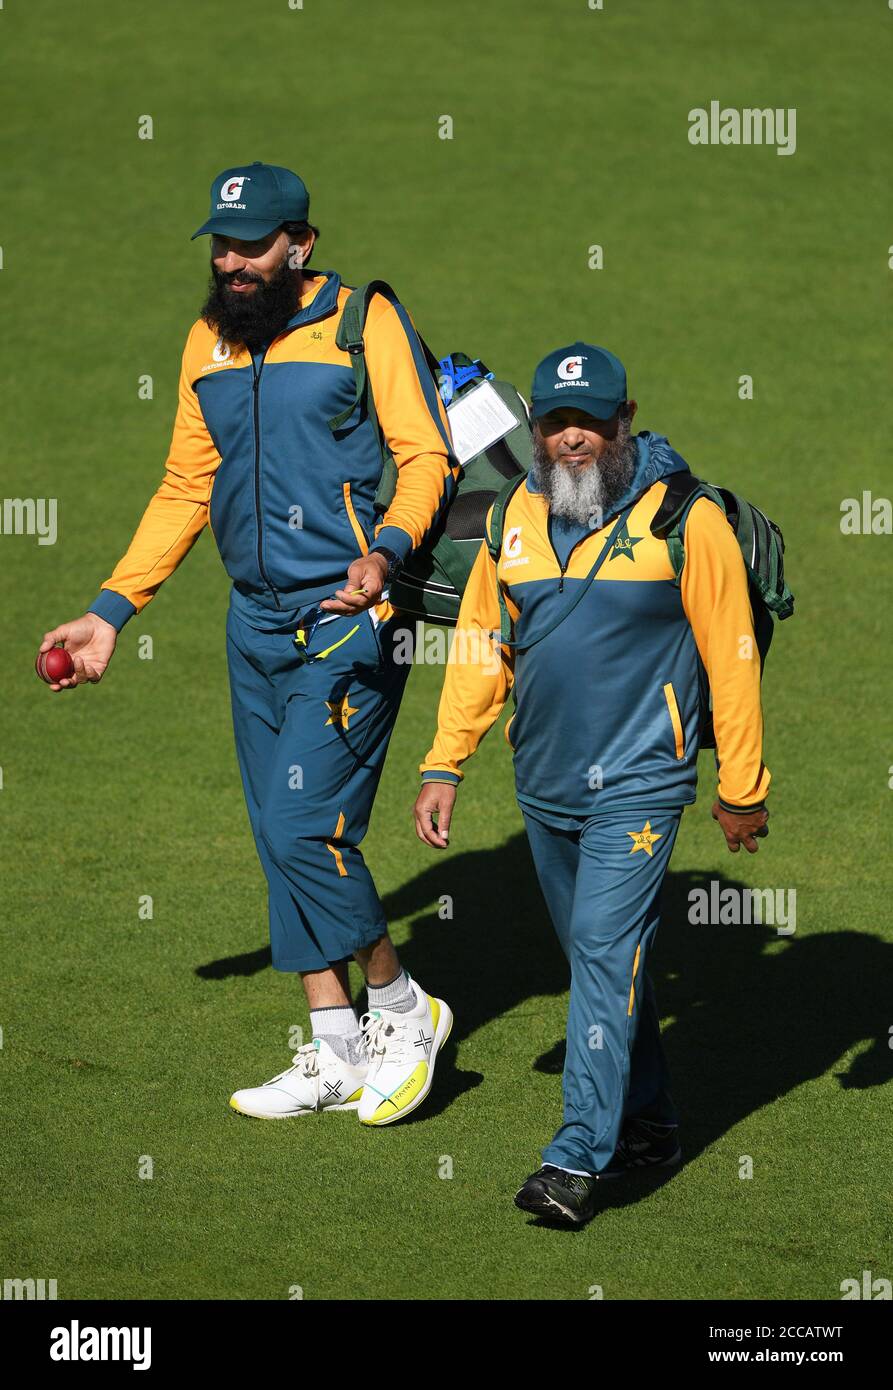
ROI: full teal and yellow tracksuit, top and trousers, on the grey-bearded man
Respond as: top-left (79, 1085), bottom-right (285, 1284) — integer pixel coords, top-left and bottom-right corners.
top-left (421, 432), bottom-right (769, 1172)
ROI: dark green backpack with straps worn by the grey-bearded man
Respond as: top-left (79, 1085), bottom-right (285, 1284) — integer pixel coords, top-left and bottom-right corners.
top-left (487, 473), bottom-right (794, 748)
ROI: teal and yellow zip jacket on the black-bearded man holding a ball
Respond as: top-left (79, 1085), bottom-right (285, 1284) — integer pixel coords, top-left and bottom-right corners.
top-left (90, 271), bottom-right (458, 630)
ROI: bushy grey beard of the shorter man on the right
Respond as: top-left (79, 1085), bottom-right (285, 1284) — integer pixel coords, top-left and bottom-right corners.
top-left (533, 418), bottom-right (638, 527)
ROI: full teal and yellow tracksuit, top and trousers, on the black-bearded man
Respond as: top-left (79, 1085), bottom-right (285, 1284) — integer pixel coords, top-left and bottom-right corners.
top-left (90, 271), bottom-right (458, 970)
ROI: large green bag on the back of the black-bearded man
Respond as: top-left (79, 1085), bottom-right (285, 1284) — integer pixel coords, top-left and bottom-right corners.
top-left (328, 279), bottom-right (533, 626)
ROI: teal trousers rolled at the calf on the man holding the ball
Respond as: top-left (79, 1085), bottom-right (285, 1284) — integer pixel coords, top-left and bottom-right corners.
top-left (227, 599), bottom-right (412, 972)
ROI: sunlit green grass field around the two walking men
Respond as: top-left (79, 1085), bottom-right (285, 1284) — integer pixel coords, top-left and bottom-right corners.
top-left (0, 0), bottom-right (893, 1300)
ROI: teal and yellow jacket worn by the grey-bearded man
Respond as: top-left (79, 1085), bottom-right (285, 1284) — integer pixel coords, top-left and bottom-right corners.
top-left (420, 432), bottom-right (769, 817)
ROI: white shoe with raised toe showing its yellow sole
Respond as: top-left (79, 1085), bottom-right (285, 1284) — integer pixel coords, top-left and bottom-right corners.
top-left (359, 980), bottom-right (452, 1125)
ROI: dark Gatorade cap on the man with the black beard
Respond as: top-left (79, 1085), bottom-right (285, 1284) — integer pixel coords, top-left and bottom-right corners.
top-left (192, 160), bottom-right (310, 242)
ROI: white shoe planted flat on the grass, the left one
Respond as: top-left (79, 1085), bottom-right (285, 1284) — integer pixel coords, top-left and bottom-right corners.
top-left (230, 1038), bottom-right (369, 1120)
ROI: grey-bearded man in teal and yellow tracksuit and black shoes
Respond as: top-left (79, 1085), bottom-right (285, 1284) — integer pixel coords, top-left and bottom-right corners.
top-left (415, 342), bottom-right (769, 1225)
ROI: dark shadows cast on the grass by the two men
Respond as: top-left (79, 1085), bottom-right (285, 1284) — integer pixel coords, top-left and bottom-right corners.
top-left (198, 834), bottom-right (893, 1207)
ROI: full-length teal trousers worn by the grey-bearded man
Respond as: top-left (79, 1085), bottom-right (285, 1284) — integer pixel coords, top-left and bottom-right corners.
top-left (522, 805), bottom-right (682, 1173)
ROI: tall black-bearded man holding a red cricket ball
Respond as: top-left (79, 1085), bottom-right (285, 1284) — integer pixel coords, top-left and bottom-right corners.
top-left (40, 163), bottom-right (458, 1126)
